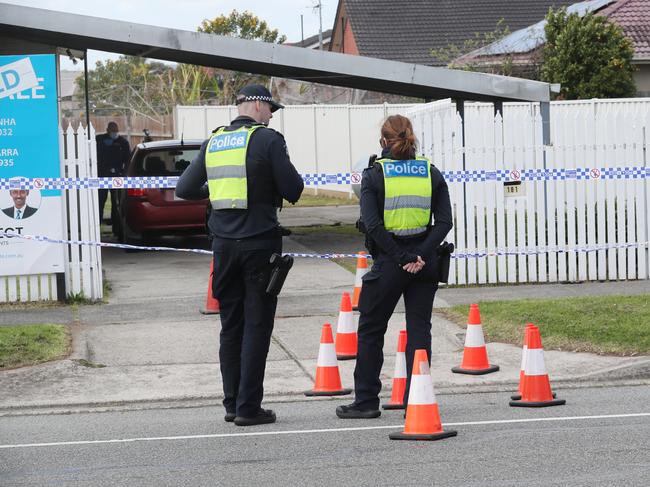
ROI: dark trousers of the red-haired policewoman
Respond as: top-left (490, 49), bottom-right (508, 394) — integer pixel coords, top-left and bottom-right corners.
top-left (354, 255), bottom-right (438, 409)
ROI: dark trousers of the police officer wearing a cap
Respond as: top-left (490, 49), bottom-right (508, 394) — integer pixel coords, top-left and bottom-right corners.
top-left (212, 230), bottom-right (282, 417)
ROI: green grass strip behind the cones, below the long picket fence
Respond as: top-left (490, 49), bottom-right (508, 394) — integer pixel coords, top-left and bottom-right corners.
top-left (442, 294), bottom-right (650, 355)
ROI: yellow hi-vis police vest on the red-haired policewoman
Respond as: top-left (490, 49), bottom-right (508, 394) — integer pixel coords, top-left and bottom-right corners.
top-left (376, 158), bottom-right (431, 237)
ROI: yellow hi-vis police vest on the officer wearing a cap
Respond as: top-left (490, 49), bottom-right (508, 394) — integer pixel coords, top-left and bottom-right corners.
top-left (205, 125), bottom-right (263, 210)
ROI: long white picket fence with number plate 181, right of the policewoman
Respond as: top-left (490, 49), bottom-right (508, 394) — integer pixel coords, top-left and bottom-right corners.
top-left (408, 99), bottom-right (650, 284)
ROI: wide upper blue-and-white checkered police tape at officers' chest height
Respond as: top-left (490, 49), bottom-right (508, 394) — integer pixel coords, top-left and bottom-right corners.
top-left (0, 166), bottom-right (650, 190)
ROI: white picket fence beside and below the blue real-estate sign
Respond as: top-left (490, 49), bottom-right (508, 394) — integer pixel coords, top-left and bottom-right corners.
top-left (0, 125), bottom-right (103, 302)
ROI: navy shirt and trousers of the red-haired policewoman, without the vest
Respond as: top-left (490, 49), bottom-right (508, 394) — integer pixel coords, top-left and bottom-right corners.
top-left (337, 149), bottom-right (452, 417)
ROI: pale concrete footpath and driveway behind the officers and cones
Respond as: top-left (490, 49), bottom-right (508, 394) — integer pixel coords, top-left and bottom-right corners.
top-left (0, 208), bottom-right (650, 415)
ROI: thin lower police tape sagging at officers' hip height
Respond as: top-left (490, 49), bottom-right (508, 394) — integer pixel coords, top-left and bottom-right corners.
top-left (0, 231), bottom-right (650, 259)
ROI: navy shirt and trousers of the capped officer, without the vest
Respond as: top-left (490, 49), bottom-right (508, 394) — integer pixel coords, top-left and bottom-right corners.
top-left (176, 109), bottom-right (304, 425)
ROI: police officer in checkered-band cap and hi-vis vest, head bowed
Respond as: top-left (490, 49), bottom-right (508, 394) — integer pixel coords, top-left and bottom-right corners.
top-left (176, 85), bottom-right (304, 426)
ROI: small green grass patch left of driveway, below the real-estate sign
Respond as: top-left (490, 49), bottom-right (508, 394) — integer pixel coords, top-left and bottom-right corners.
top-left (0, 324), bottom-right (70, 369)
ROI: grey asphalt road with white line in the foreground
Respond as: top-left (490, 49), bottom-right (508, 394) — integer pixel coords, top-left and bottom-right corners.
top-left (0, 386), bottom-right (650, 487)
